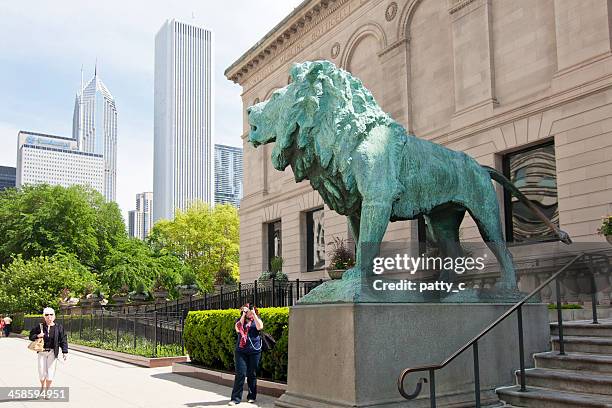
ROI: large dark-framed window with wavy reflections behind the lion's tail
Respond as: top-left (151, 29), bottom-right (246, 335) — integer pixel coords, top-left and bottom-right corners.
top-left (503, 142), bottom-right (559, 243)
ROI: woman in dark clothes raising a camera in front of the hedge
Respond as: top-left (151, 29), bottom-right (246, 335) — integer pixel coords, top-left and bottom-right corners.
top-left (228, 303), bottom-right (263, 405)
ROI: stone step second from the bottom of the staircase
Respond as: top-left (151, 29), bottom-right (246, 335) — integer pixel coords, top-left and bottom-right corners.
top-left (516, 368), bottom-right (612, 397)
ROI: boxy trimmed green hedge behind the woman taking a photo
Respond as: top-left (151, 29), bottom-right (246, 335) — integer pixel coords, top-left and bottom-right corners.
top-left (183, 307), bottom-right (289, 381)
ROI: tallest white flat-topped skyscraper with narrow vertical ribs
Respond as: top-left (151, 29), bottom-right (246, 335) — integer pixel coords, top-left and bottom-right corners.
top-left (153, 19), bottom-right (215, 221)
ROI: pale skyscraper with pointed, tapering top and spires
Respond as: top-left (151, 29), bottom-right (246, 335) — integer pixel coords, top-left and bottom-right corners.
top-left (72, 67), bottom-right (117, 201)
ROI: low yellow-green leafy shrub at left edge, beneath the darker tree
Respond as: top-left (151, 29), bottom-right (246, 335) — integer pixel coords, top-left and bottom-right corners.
top-left (0, 252), bottom-right (98, 313)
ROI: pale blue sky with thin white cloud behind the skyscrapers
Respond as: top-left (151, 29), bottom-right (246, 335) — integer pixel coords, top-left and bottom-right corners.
top-left (0, 0), bottom-right (301, 222)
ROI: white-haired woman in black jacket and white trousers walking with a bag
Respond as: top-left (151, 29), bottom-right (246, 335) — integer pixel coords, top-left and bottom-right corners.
top-left (30, 307), bottom-right (68, 398)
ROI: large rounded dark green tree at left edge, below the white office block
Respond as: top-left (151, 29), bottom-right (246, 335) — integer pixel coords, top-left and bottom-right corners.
top-left (0, 184), bottom-right (126, 271)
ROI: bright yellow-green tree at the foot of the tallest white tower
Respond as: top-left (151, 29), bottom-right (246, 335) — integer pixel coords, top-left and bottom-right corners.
top-left (149, 202), bottom-right (239, 291)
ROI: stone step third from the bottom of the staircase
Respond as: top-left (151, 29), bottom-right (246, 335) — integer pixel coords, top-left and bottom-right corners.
top-left (533, 351), bottom-right (612, 374)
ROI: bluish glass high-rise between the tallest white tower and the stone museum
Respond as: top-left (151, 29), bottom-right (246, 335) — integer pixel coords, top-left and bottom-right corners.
top-left (215, 144), bottom-right (242, 207)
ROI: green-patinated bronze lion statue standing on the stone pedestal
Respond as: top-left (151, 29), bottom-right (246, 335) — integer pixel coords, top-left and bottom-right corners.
top-left (247, 61), bottom-right (569, 289)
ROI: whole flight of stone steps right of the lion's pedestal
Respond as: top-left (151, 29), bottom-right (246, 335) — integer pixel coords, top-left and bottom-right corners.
top-left (496, 319), bottom-right (612, 408)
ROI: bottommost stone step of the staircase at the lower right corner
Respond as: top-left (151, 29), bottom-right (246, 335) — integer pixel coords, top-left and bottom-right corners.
top-left (495, 386), bottom-right (612, 408)
